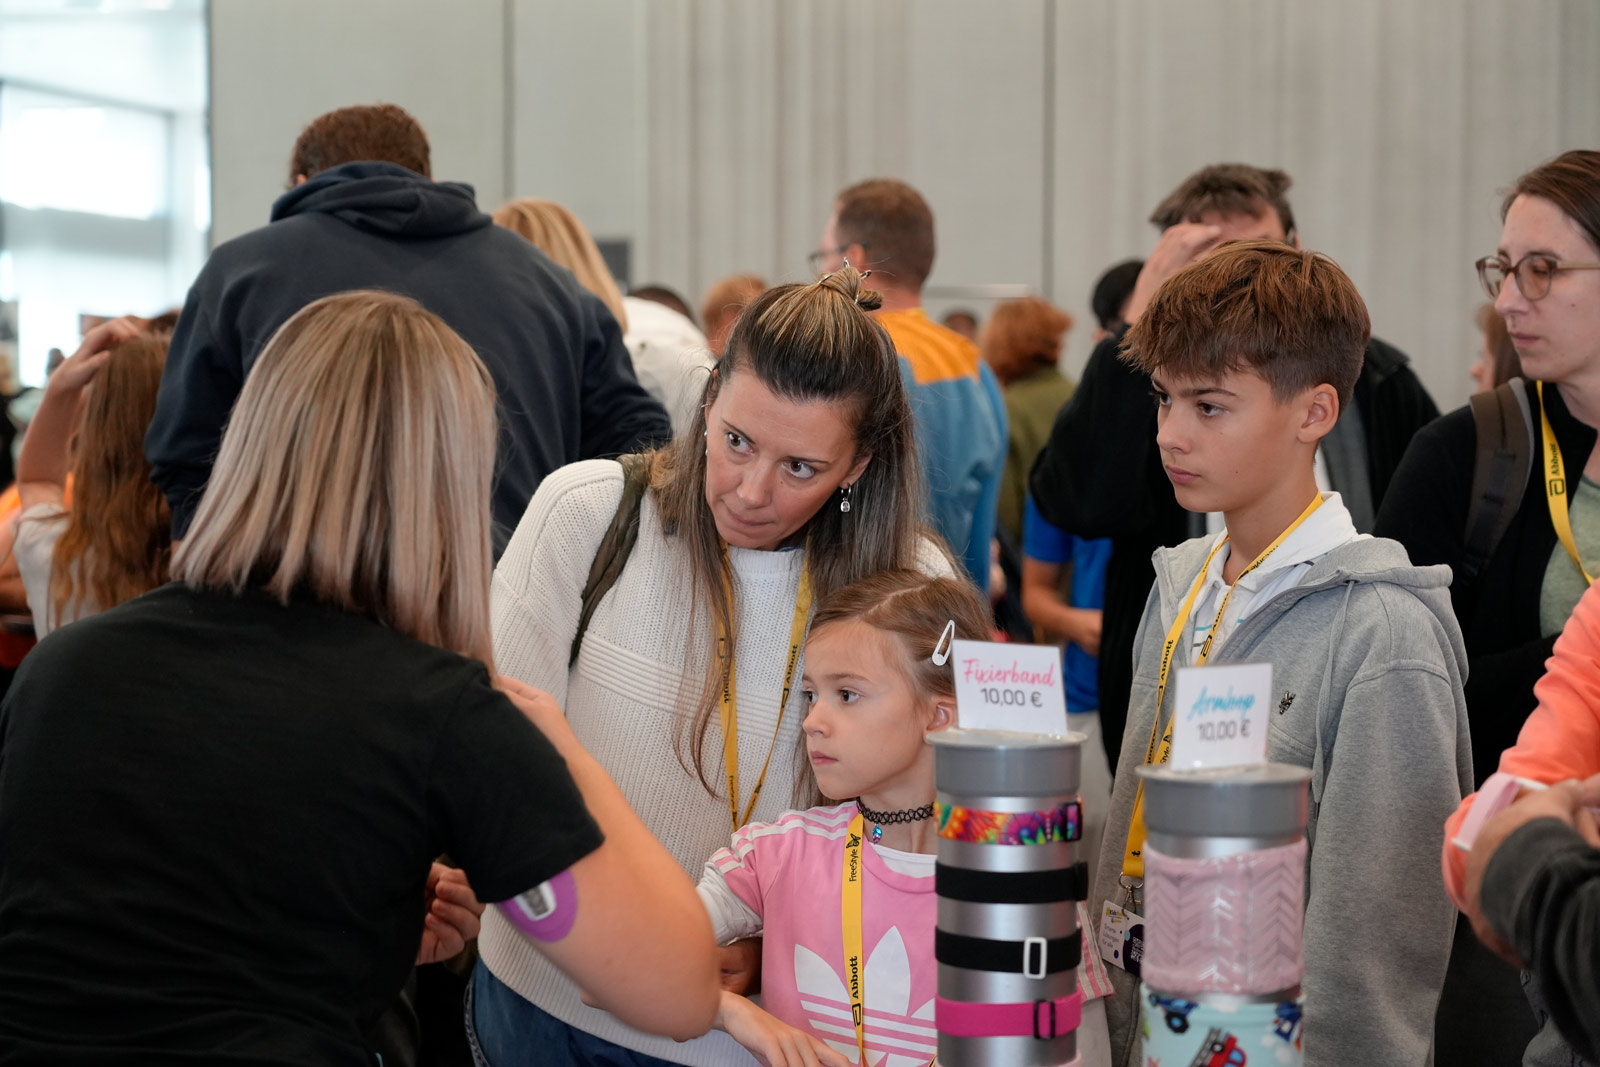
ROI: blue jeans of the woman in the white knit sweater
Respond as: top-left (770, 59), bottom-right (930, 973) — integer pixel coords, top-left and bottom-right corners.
top-left (466, 960), bottom-right (674, 1067)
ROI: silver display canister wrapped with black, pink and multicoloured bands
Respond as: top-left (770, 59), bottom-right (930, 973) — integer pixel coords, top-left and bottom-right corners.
top-left (933, 729), bottom-right (1086, 1067)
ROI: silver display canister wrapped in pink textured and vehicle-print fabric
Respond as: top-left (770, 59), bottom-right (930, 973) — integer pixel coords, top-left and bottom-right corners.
top-left (1138, 763), bottom-right (1310, 1064)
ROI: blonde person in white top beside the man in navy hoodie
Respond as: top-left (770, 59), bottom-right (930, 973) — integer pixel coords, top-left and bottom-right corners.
top-left (494, 197), bottom-right (712, 430)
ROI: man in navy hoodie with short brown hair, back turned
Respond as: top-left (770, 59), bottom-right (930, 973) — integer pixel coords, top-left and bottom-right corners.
top-left (144, 104), bottom-right (672, 557)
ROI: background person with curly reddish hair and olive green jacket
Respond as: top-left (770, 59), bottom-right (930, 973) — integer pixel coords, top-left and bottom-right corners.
top-left (978, 296), bottom-right (1072, 544)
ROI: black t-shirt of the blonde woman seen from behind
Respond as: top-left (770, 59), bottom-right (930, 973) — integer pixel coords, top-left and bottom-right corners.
top-left (0, 584), bottom-right (600, 1064)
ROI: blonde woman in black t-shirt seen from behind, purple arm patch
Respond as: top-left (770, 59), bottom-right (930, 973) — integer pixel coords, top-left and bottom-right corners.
top-left (0, 291), bottom-right (718, 1067)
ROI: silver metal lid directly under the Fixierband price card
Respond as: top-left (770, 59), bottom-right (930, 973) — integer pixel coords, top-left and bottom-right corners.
top-left (930, 729), bottom-right (1088, 797)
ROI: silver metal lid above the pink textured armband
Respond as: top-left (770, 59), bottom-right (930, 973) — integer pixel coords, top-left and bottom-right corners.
top-left (1138, 763), bottom-right (1310, 838)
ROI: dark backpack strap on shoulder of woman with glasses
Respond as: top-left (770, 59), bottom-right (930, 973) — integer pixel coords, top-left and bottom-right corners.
top-left (1456, 378), bottom-right (1534, 581)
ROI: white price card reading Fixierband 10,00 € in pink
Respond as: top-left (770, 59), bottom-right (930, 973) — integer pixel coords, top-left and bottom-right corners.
top-left (950, 640), bottom-right (1067, 734)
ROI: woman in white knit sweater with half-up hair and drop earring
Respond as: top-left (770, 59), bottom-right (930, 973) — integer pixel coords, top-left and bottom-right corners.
top-left (470, 267), bottom-right (954, 1067)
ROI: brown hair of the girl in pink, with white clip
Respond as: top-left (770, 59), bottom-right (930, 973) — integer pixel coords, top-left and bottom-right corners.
top-left (811, 569), bottom-right (990, 710)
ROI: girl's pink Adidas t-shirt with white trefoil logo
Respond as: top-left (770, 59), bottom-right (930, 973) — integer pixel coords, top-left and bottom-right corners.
top-left (699, 803), bottom-right (938, 1067)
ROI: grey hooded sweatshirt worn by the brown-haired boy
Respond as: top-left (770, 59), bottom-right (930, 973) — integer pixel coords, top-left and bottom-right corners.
top-left (1090, 537), bottom-right (1472, 1067)
